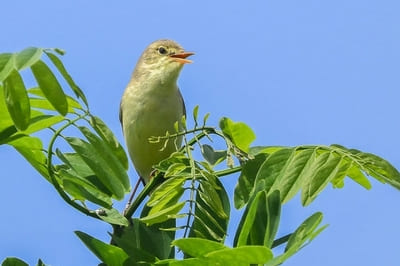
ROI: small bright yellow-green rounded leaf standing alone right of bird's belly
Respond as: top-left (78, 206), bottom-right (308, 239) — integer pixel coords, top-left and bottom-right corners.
top-left (219, 117), bottom-right (256, 152)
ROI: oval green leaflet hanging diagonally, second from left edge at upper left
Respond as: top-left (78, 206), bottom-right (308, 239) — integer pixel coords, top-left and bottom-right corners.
top-left (31, 60), bottom-right (68, 116)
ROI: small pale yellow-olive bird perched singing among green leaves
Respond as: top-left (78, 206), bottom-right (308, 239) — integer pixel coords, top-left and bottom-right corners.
top-left (119, 39), bottom-right (194, 184)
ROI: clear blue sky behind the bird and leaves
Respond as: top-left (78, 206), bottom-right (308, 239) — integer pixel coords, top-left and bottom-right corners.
top-left (0, 0), bottom-right (400, 266)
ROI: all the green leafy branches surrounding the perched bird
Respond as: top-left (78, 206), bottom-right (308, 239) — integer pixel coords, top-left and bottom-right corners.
top-left (0, 47), bottom-right (400, 266)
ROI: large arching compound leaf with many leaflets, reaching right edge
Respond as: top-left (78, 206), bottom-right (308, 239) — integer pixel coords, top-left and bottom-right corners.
top-left (241, 145), bottom-right (400, 207)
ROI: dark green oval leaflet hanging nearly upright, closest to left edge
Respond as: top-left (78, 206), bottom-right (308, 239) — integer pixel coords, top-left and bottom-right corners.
top-left (4, 70), bottom-right (31, 130)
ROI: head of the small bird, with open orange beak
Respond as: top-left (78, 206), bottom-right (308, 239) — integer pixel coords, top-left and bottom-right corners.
top-left (135, 40), bottom-right (194, 82)
